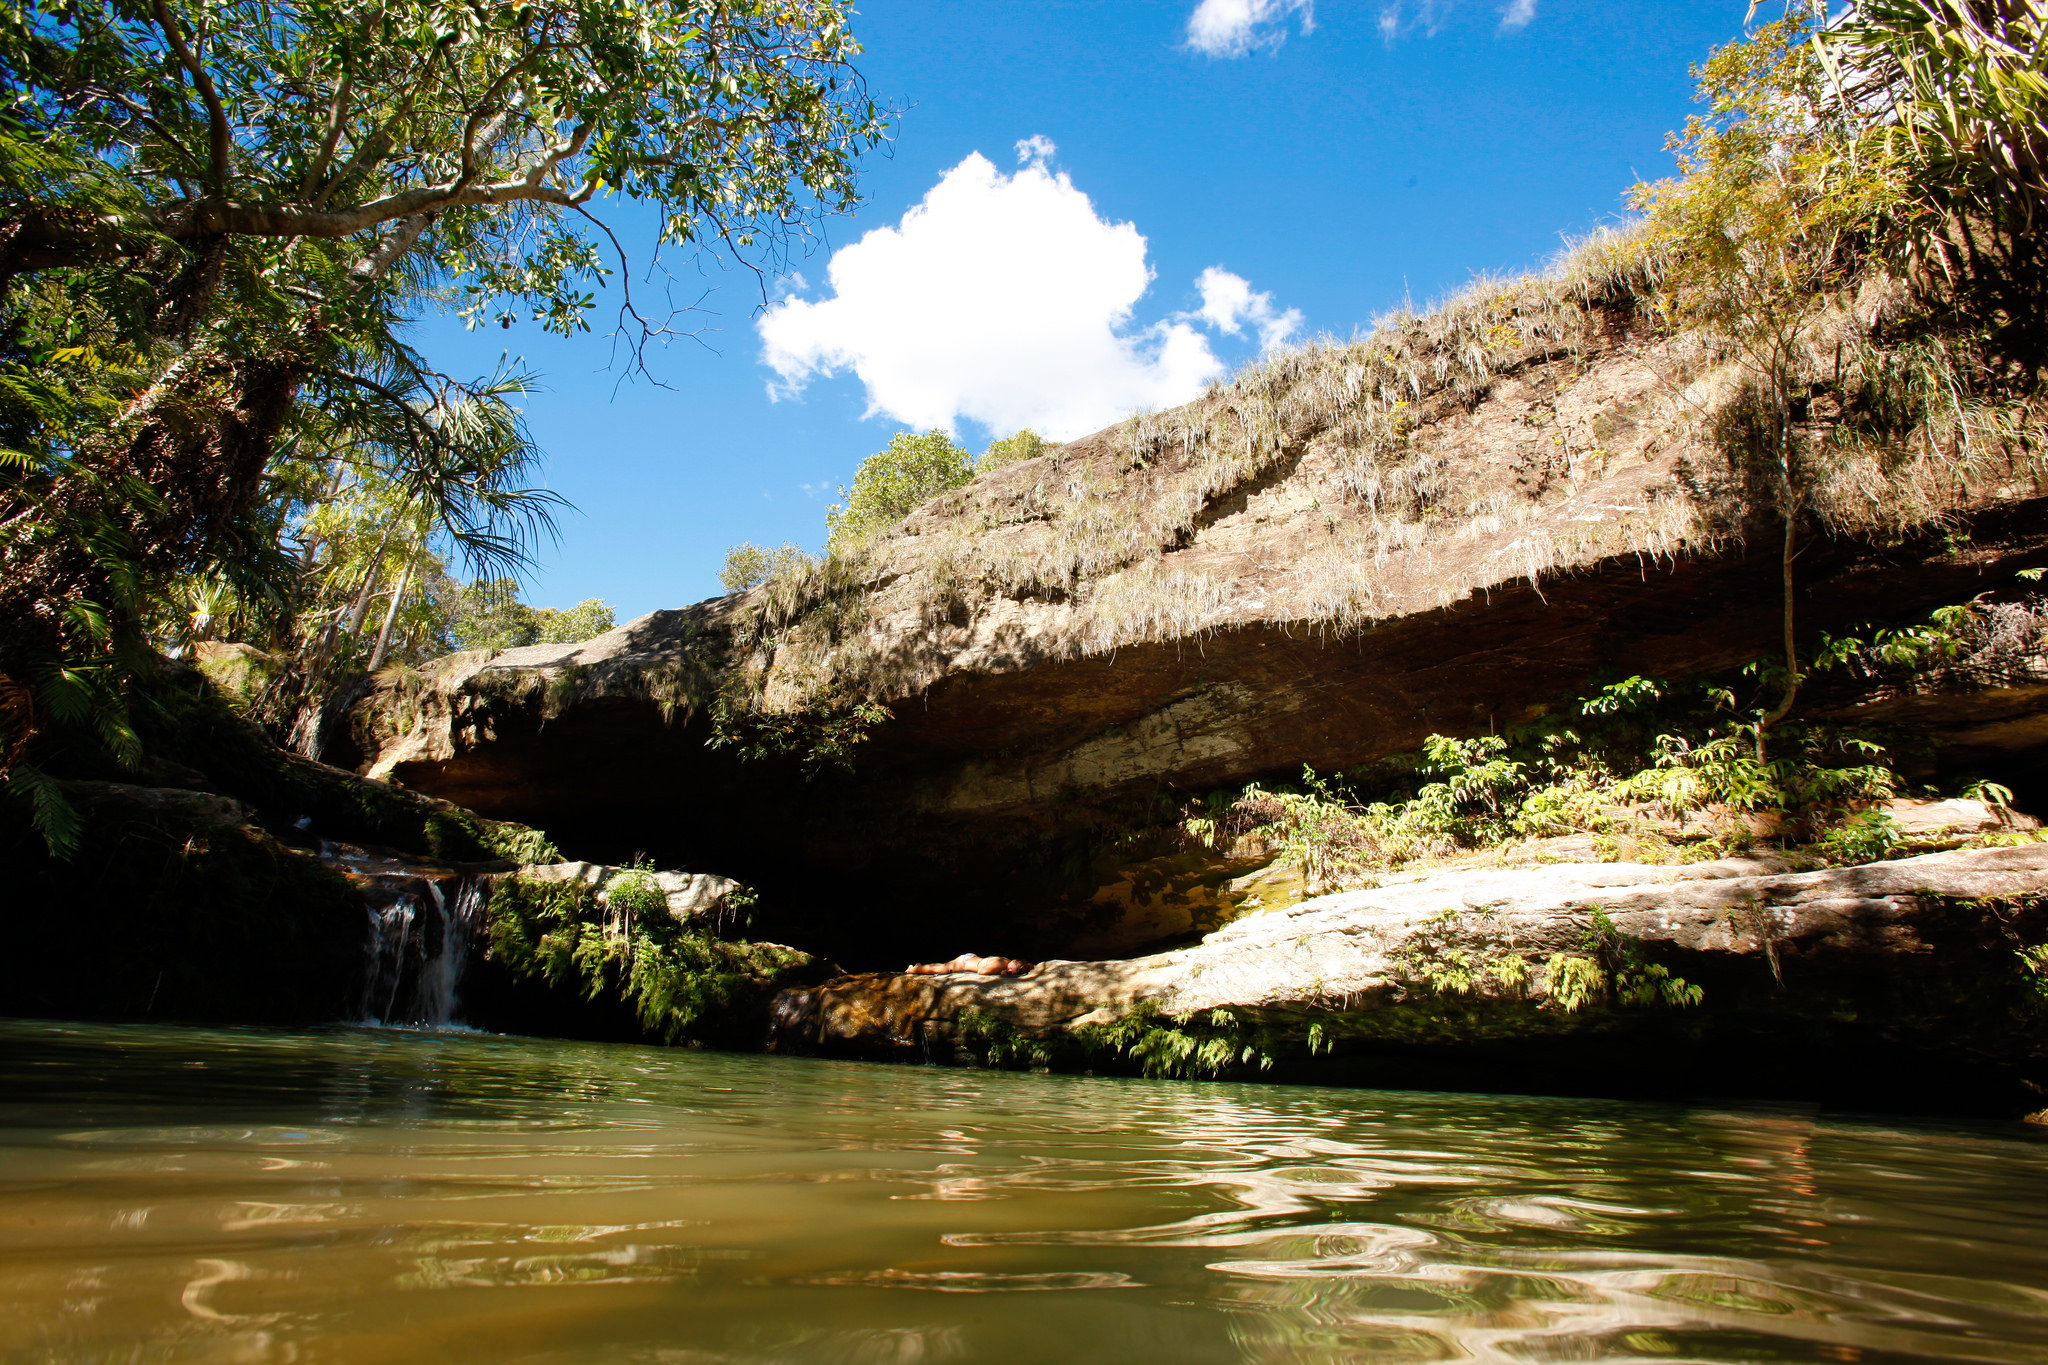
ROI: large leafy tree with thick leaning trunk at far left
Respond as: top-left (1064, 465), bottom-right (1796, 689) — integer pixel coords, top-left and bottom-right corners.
top-left (0, 0), bottom-right (885, 847)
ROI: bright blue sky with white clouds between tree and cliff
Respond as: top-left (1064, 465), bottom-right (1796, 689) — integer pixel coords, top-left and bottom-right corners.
top-left (416, 0), bottom-right (1747, 620)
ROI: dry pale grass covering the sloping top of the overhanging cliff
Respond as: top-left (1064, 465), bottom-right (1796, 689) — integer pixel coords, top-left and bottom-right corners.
top-left (735, 213), bottom-right (2048, 708)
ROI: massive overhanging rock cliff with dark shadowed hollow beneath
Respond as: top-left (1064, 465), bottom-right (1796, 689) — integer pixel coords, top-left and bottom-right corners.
top-left (350, 299), bottom-right (2048, 964)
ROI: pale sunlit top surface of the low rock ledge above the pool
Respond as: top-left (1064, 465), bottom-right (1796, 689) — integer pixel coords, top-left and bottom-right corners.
top-left (776, 843), bottom-right (2048, 1052)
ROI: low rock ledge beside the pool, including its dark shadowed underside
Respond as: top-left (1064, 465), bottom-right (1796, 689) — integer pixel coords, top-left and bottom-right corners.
top-left (774, 843), bottom-right (2048, 1117)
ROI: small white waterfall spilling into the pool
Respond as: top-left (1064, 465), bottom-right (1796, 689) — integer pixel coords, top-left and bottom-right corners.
top-left (356, 874), bottom-right (485, 1029)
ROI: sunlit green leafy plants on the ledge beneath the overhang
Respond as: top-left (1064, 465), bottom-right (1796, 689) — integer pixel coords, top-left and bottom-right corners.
top-left (1184, 585), bottom-right (2048, 892)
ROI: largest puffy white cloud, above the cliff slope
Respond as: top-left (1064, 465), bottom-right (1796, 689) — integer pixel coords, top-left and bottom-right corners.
top-left (758, 150), bottom-right (1300, 440)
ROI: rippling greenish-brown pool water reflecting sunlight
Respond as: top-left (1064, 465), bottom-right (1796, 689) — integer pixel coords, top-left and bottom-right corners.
top-left (0, 1023), bottom-right (2048, 1365)
